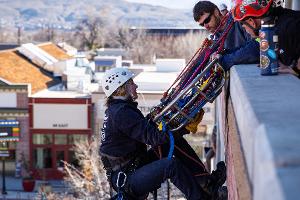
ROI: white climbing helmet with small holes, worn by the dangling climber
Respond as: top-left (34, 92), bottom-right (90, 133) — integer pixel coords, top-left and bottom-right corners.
top-left (101, 67), bottom-right (134, 97)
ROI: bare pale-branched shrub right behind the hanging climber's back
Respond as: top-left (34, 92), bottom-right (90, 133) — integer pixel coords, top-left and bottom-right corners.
top-left (64, 139), bottom-right (109, 199)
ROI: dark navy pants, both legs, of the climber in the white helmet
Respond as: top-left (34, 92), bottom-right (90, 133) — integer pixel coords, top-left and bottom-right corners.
top-left (112, 137), bottom-right (207, 199)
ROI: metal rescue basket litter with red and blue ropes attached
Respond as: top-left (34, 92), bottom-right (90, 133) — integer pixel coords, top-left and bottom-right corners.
top-left (149, 14), bottom-right (234, 131)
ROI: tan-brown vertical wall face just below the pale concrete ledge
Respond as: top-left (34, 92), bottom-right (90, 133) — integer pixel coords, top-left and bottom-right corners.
top-left (218, 90), bottom-right (252, 200)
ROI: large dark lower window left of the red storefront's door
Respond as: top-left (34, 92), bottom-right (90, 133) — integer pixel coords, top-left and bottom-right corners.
top-left (33, 148), bottom-right (52, 169)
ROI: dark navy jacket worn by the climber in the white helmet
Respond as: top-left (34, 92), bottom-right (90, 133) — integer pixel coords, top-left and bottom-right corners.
top-left (100, 100), bottom-right (168, 157)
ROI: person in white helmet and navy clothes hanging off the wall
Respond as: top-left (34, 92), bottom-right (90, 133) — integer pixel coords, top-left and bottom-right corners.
top-left (100, 68), bottom-right (223, 200)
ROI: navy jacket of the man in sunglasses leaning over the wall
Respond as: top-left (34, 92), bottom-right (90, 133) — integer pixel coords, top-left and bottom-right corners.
top-left (220, 14), bottom-right (259, 70)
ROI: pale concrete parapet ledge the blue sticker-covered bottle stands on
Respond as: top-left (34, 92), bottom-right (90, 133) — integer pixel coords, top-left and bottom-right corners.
top-left (229, 65), bottom-right (300, 200)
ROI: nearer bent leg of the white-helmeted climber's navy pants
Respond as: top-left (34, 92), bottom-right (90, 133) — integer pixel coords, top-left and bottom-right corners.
top-left (111, 158), bottom-right (205, 200)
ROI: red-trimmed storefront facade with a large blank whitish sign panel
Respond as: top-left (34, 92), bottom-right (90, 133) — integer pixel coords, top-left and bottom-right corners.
top-left (29, 97), bottom-right (92, 179)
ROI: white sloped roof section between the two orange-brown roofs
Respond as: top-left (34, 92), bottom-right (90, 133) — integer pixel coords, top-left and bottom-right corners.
top-left (18, 43), bottom-right (58, 71)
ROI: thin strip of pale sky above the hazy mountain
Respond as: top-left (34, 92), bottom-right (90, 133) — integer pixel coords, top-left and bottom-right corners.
top-left (126, 0), bottom-right (231, 10)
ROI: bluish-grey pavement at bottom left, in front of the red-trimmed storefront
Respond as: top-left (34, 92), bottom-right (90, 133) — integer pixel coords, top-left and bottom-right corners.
top-left (0, 176), bottom-right (67, 200)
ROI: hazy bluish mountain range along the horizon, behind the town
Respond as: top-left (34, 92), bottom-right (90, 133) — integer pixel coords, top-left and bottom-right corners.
top-left (0, 0), bottom-right (195, 29)
